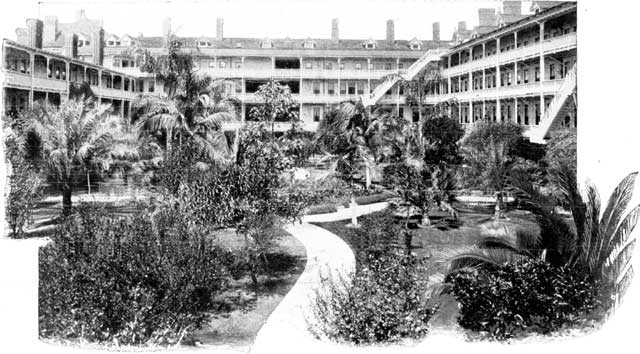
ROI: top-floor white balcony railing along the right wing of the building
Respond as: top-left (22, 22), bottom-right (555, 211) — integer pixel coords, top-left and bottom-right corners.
top-left (442, 32), bottom-right (577, 77)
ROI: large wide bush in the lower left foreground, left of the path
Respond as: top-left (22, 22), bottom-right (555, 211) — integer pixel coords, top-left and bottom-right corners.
top-left (39, 206), bottom-right (235, 345)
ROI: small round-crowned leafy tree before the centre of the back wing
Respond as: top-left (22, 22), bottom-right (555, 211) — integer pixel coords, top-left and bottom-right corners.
top-left (249, 79), bottom-right (299, 138)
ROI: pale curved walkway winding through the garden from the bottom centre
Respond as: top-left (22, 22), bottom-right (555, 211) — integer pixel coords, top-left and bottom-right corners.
top-left (251, 203), bottom-right (387, 353)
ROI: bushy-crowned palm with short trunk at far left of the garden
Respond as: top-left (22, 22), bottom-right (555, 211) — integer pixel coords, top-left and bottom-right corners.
top-left (24, 99), bottom-right (126, 215)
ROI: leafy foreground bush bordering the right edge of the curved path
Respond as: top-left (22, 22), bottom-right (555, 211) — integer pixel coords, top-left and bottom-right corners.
top-left (311, 250), bottom-right (436, 344)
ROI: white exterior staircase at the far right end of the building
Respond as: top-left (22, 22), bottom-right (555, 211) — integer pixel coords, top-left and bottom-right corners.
top-left (527, 65), bottom-right (577, 144)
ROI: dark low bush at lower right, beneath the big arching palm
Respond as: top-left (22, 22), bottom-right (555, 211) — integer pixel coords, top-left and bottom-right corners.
top-left (445, 260), bottom-right (600, 340)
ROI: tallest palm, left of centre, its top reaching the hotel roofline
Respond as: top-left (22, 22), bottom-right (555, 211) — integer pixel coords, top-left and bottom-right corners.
top-left (133, 34), bottom-right (238, 164)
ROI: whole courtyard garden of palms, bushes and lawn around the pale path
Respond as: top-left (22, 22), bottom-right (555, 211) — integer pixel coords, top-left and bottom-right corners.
top-left (3, 31), bottom-right (640, 350)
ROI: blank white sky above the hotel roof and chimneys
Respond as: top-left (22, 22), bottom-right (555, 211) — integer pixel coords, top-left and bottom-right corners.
top-left (0, 0), bottom-right (510, 39)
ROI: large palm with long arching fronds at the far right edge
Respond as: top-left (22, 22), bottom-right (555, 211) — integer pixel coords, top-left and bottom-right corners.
top-left (450, 164), bottom-right (640, 304)
